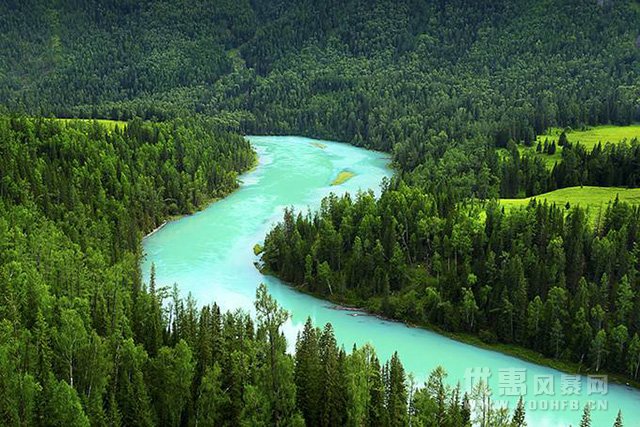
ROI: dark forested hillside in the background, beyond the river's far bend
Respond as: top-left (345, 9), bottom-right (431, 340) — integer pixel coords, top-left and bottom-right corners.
top-left (0, 0), bottom-right (640, 155)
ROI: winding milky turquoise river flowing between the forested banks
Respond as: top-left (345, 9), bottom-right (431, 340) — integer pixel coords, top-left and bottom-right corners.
top-left (142, 136), bottom-right (640, 427)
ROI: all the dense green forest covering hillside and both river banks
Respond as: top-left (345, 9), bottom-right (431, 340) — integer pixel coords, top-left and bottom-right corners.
top-left (0, 0), bottom-right (640, 426)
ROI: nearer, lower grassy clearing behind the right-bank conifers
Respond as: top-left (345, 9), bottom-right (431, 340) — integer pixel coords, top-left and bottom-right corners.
top-left (500, 186), bottom-right (640, 218)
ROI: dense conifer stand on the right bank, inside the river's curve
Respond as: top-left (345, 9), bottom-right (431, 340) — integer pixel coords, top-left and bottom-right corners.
top-left (262, 181), bottom-right (640, 378)
